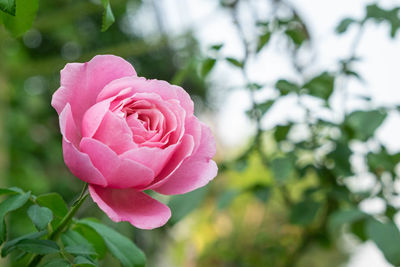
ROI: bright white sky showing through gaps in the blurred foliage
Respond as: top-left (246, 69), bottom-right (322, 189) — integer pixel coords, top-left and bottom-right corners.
top-left (133, 0), bottom-right (400, 267)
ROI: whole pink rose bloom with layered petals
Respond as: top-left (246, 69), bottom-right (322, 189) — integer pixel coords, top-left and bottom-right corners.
top-left (51, 55), bottom-right (217, 229)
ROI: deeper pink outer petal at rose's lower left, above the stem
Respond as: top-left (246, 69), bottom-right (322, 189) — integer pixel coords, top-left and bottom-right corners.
top-left (63, 138), bottom-right (107, 186)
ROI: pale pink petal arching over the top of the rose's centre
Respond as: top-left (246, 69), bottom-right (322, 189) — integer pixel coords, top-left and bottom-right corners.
top-left (97, 77), bottom-right (193, 115)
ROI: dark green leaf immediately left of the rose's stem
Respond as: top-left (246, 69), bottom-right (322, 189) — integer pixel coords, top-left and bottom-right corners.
top-left (36, 193), bottom-right (68, 228)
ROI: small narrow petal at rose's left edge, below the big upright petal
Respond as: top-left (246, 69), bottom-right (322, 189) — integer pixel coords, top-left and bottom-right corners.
top-left (60, 104), bottom-right (81, 148)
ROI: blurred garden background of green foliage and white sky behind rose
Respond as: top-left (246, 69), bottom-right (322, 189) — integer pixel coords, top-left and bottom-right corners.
top-left (0, 0), bottom-right (400, 267)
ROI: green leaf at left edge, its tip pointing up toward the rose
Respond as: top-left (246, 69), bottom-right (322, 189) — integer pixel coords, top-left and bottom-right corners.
top-left (0, 192), bottom-right (31, 244)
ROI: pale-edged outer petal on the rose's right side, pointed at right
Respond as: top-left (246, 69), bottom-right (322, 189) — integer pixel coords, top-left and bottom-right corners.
top-left (154, 124), bottom-right (218, 195)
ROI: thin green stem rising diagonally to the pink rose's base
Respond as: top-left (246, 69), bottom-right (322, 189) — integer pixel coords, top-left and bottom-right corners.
top-left (28, 183), bottom-right (89, 267)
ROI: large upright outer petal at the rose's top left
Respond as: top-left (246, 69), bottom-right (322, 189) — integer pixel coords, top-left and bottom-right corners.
top-left (51, 55), bottom-right (136, 129)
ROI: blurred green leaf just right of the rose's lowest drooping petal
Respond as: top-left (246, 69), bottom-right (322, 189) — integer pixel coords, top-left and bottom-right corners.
top-left (168, 187), bottom-right (207, 224)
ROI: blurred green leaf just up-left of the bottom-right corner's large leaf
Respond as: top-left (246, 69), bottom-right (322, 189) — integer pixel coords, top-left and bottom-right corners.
top-left (328, 209), bottom-right (369, 232)
